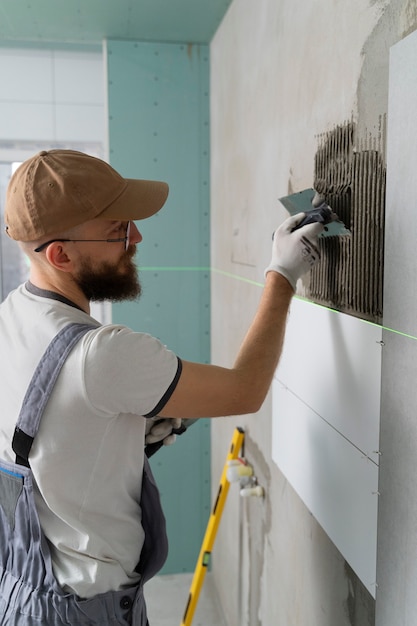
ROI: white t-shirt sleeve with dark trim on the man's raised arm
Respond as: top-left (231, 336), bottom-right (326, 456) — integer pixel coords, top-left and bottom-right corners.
top-left (83, 325), bottom-right (181, 417)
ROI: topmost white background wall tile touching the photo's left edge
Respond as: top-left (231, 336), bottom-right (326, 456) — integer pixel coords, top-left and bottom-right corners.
top-left (0, 48), bottom-right (53, 103)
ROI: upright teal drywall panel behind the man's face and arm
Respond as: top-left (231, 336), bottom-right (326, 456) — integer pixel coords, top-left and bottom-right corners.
top-left (106, 41), bottom-right (210, 573)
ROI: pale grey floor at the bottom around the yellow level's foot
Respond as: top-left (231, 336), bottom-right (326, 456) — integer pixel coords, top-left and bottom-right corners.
top-left (145, 572), bottom-right (227, 626)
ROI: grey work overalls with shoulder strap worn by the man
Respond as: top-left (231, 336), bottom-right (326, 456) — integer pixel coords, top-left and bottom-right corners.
top-left (0, 324), bottom-right (168, 626)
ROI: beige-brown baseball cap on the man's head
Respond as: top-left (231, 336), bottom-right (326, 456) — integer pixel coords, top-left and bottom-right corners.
top-left (4, 150), bottom-right (168, 241)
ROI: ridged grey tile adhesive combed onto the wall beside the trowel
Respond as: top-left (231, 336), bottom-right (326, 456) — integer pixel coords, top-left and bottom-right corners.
top-left (304, 117), bottom-right (386, 323)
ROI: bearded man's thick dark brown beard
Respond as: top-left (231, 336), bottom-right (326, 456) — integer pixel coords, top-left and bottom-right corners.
top-left (74, 247), bottom-right (142, 302)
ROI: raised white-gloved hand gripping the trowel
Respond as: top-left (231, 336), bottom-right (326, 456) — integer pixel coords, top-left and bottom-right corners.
top-left (265, 213), bottom-right (324, 291)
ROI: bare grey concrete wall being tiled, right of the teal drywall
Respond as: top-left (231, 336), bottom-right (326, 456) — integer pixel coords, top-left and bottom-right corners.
top-left (211, 0), bottom-right (417, 626)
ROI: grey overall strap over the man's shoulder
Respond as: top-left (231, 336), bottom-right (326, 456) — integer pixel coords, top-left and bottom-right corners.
top-left (12, 323), bottom-right (97, 467)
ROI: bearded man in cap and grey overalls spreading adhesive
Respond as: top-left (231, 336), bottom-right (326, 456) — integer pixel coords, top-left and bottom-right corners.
top-left (0, 150), bottom-right (322, 626)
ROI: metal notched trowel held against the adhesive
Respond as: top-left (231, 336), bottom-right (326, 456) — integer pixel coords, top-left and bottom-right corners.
top-left (279, 189), bottom-right (351, 237)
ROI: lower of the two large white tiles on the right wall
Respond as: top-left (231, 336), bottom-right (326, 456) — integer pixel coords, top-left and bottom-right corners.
top-left (272, 379), bottom-right (378, 597)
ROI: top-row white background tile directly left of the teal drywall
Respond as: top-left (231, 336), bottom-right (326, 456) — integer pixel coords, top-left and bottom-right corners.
top-left (53, 51), bottom-right (104, 105)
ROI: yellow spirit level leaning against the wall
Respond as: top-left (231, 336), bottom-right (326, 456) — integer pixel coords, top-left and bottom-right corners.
top-left (181, 427), bottom-right (245, 626)
